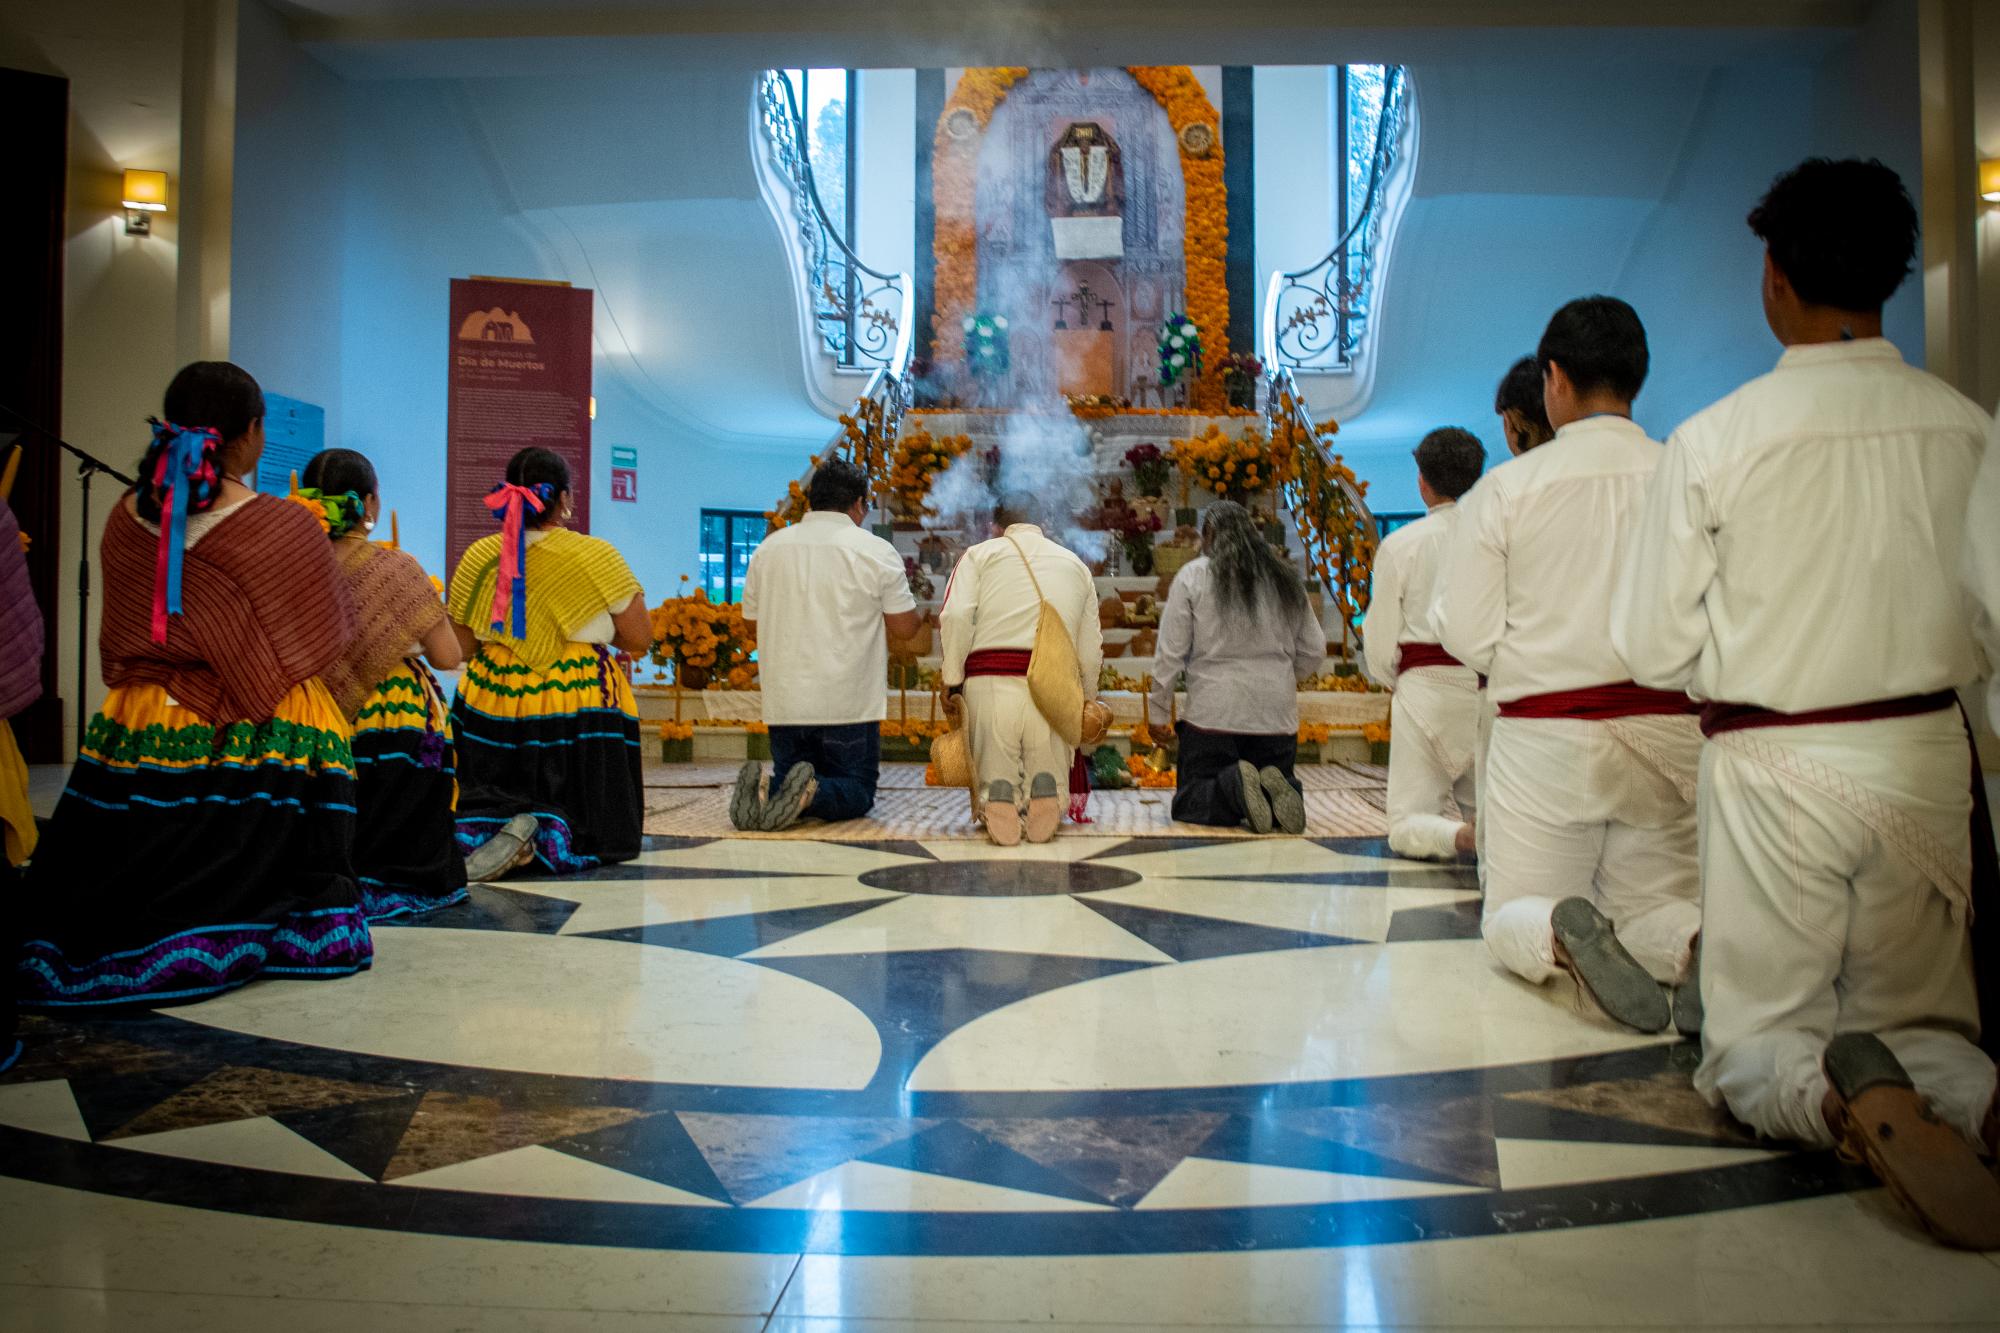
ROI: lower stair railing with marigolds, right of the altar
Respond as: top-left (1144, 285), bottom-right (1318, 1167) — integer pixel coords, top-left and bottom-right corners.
top-left (1264, 366), bottom-right (1380, 656)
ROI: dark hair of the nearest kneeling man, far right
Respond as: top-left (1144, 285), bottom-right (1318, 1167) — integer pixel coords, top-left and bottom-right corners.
top-left (1750, 158), bottom-right (1918, 314)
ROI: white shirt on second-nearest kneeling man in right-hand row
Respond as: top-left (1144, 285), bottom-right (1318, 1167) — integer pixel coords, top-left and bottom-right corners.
top-left (1436, 416), bottom-right (1660, 703)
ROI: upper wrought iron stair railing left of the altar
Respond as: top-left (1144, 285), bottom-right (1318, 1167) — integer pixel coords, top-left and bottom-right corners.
top-left (758, 70), bottom-right (916, 378)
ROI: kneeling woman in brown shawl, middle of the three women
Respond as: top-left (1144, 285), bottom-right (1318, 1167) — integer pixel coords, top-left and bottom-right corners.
top-left (296, 448), bottom-right (466, 921)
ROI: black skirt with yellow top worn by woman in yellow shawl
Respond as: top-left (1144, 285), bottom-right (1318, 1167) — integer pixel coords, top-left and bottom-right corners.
top-left (452, 642), bottom-right (644, 875)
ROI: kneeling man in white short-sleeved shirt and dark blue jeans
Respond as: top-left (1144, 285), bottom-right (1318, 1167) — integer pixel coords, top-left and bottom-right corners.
top-left (730, 458), bottom-right (920, 833)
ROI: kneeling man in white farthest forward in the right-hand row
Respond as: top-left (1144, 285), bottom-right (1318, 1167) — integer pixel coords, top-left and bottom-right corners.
top-left (1362, 426), bottom-right (1486, 861)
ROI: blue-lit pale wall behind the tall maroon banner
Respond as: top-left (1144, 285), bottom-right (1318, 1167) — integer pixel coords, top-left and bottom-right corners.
top-left (234, 18), bottom-right (824, 598)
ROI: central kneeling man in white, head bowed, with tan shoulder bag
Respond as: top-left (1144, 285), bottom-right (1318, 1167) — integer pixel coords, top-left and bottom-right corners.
top-left (938, 496), bottom-right (1104, 847)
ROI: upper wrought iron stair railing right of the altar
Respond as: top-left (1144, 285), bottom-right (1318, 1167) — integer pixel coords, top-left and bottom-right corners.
top-left (1264, 64), bottom-right (1410, 372)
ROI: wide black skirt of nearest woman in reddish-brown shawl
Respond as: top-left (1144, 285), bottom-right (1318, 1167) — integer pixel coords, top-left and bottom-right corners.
top-left (16, 681), bottom-right (374, 1009)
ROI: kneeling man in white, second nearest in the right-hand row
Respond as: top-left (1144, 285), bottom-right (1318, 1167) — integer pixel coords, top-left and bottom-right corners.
top-left (1436, 296), bottom-right (1702, 1033)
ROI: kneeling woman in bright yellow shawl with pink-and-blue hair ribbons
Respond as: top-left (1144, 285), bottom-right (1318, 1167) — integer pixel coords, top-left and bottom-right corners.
top-left (448, 448), bottom-right (652, 881)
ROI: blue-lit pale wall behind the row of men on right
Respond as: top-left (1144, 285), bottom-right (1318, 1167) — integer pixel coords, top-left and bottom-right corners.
top-left (1320, 34), bottom-right (1924, 510)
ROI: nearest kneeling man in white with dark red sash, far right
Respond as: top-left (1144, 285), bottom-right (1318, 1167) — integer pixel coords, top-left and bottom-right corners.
top-left (1612, 158), bottom-right (2000, 1249)
